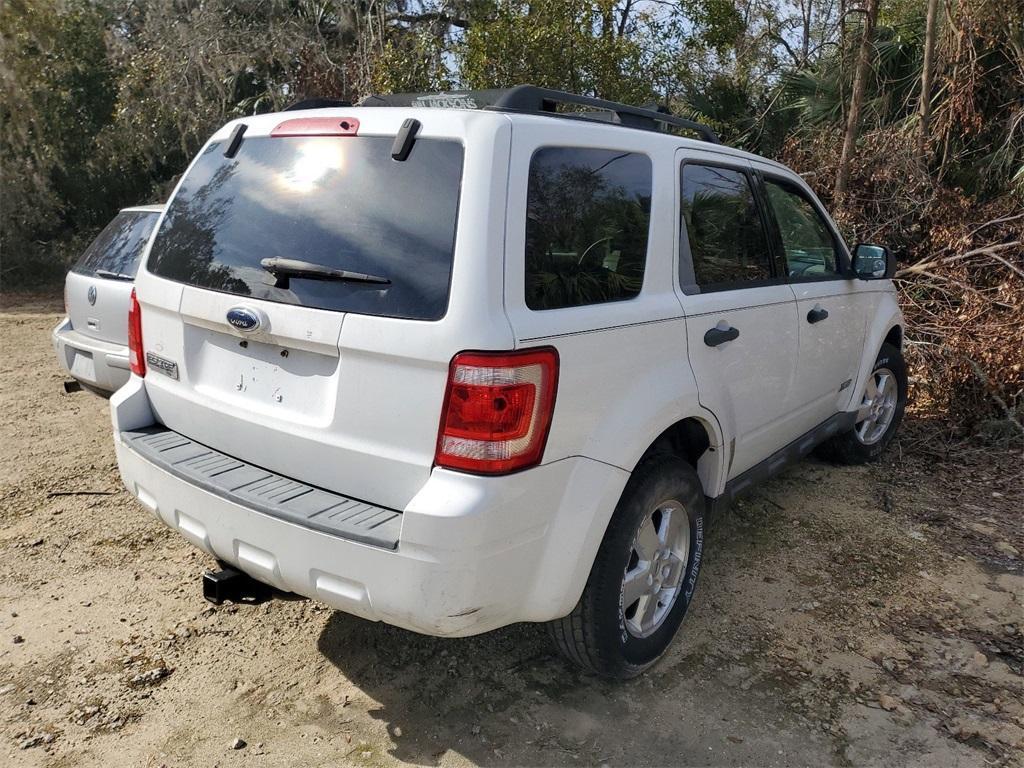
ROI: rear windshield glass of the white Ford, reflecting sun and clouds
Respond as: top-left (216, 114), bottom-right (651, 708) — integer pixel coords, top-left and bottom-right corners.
top-left (146, 136), bottom-right (463, 319)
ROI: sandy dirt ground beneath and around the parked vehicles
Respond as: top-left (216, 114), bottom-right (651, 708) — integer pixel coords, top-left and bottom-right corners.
top-left (0, 297), bottom-right (1024, 767)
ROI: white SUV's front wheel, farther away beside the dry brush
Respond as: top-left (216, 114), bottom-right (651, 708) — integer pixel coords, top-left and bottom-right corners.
top-left (822, 344), bottom-right (907, 464)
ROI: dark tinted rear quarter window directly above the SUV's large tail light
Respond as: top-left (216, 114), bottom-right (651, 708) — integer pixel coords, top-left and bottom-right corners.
top-left (526, 147), bottom-right (651, 309)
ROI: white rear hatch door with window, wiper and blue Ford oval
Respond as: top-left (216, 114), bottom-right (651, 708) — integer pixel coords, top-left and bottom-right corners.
top-left (138, 110), bottom-right (511, 509)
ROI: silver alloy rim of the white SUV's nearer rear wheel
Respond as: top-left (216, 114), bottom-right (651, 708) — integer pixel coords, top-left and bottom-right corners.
top-left (620, 500), bottom-right (690, 638)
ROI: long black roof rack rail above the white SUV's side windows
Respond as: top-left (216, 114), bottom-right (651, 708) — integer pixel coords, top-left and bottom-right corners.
top-left (356, 85), bottom-right (722, 144)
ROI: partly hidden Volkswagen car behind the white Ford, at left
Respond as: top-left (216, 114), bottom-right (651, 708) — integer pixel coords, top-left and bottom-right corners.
top-left (53, 205), bottom-right (164, 395)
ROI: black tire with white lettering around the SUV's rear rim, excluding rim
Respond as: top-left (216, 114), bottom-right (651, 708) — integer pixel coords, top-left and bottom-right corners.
top-left (548, 455), bottom-right (706, 679)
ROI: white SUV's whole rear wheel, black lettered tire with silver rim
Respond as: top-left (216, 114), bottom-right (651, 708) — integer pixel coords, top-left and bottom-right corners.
top-left (549, 456), bottom-right (705, 678)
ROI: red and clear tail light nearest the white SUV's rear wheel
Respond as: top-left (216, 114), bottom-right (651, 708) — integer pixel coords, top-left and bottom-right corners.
top-left (434, 347), bottom-right (558, 474)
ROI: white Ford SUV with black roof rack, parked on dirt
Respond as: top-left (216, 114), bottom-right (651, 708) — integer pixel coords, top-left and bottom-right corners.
top-left (112, 86), bottom-right (906, 677)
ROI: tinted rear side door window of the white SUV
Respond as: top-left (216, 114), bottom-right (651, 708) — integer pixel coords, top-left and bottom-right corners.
top-left (680, 163), bottom-right (771, 286)
